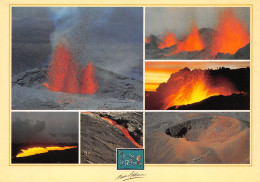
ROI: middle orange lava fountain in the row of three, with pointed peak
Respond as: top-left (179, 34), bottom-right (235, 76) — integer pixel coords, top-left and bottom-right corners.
top-left (167, 23), bottom-right (204, 56)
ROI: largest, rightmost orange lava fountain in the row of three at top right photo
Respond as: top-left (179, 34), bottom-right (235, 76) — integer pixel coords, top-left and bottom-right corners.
top-left (211, 9), bottom-right (250, 54)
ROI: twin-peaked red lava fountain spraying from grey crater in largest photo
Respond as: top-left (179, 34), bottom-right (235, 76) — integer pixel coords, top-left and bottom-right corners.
top-left (43, 42), bottom-right (98, 94)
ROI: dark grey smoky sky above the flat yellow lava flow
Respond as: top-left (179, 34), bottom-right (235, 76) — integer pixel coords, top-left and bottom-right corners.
top-left (12, 112), bottom-right (78, 144)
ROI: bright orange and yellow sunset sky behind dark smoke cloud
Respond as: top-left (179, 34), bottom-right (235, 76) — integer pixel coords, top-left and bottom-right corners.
top-left (145, 62), bottom-right (250, 91)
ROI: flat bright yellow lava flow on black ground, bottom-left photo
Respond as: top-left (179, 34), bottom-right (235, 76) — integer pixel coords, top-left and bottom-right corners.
top-left (16, 146), bottom-right (77, 157)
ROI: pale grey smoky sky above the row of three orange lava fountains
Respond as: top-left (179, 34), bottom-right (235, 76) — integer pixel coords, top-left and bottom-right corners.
top-left (145, 7), bottom-right (250, 39)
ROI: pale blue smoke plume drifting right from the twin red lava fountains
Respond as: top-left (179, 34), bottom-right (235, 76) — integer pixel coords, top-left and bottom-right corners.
top-left (49, 7), bottom-right (143, 75)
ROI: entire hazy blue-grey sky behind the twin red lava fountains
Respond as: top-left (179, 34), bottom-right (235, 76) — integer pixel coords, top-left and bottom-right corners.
top-left (12, 7), bottom-right (143, 77)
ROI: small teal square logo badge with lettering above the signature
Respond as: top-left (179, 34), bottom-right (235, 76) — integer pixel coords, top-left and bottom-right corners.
top-left (116, 149), bottom-right (144, 170)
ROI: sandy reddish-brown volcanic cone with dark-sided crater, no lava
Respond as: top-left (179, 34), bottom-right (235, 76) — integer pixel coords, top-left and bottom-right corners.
top-left (145, 114), bottom-right (250, 164)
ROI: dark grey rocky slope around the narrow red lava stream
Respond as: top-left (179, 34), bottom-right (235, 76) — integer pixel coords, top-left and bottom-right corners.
top-left (81, 112), bottom-right (143, 163)
